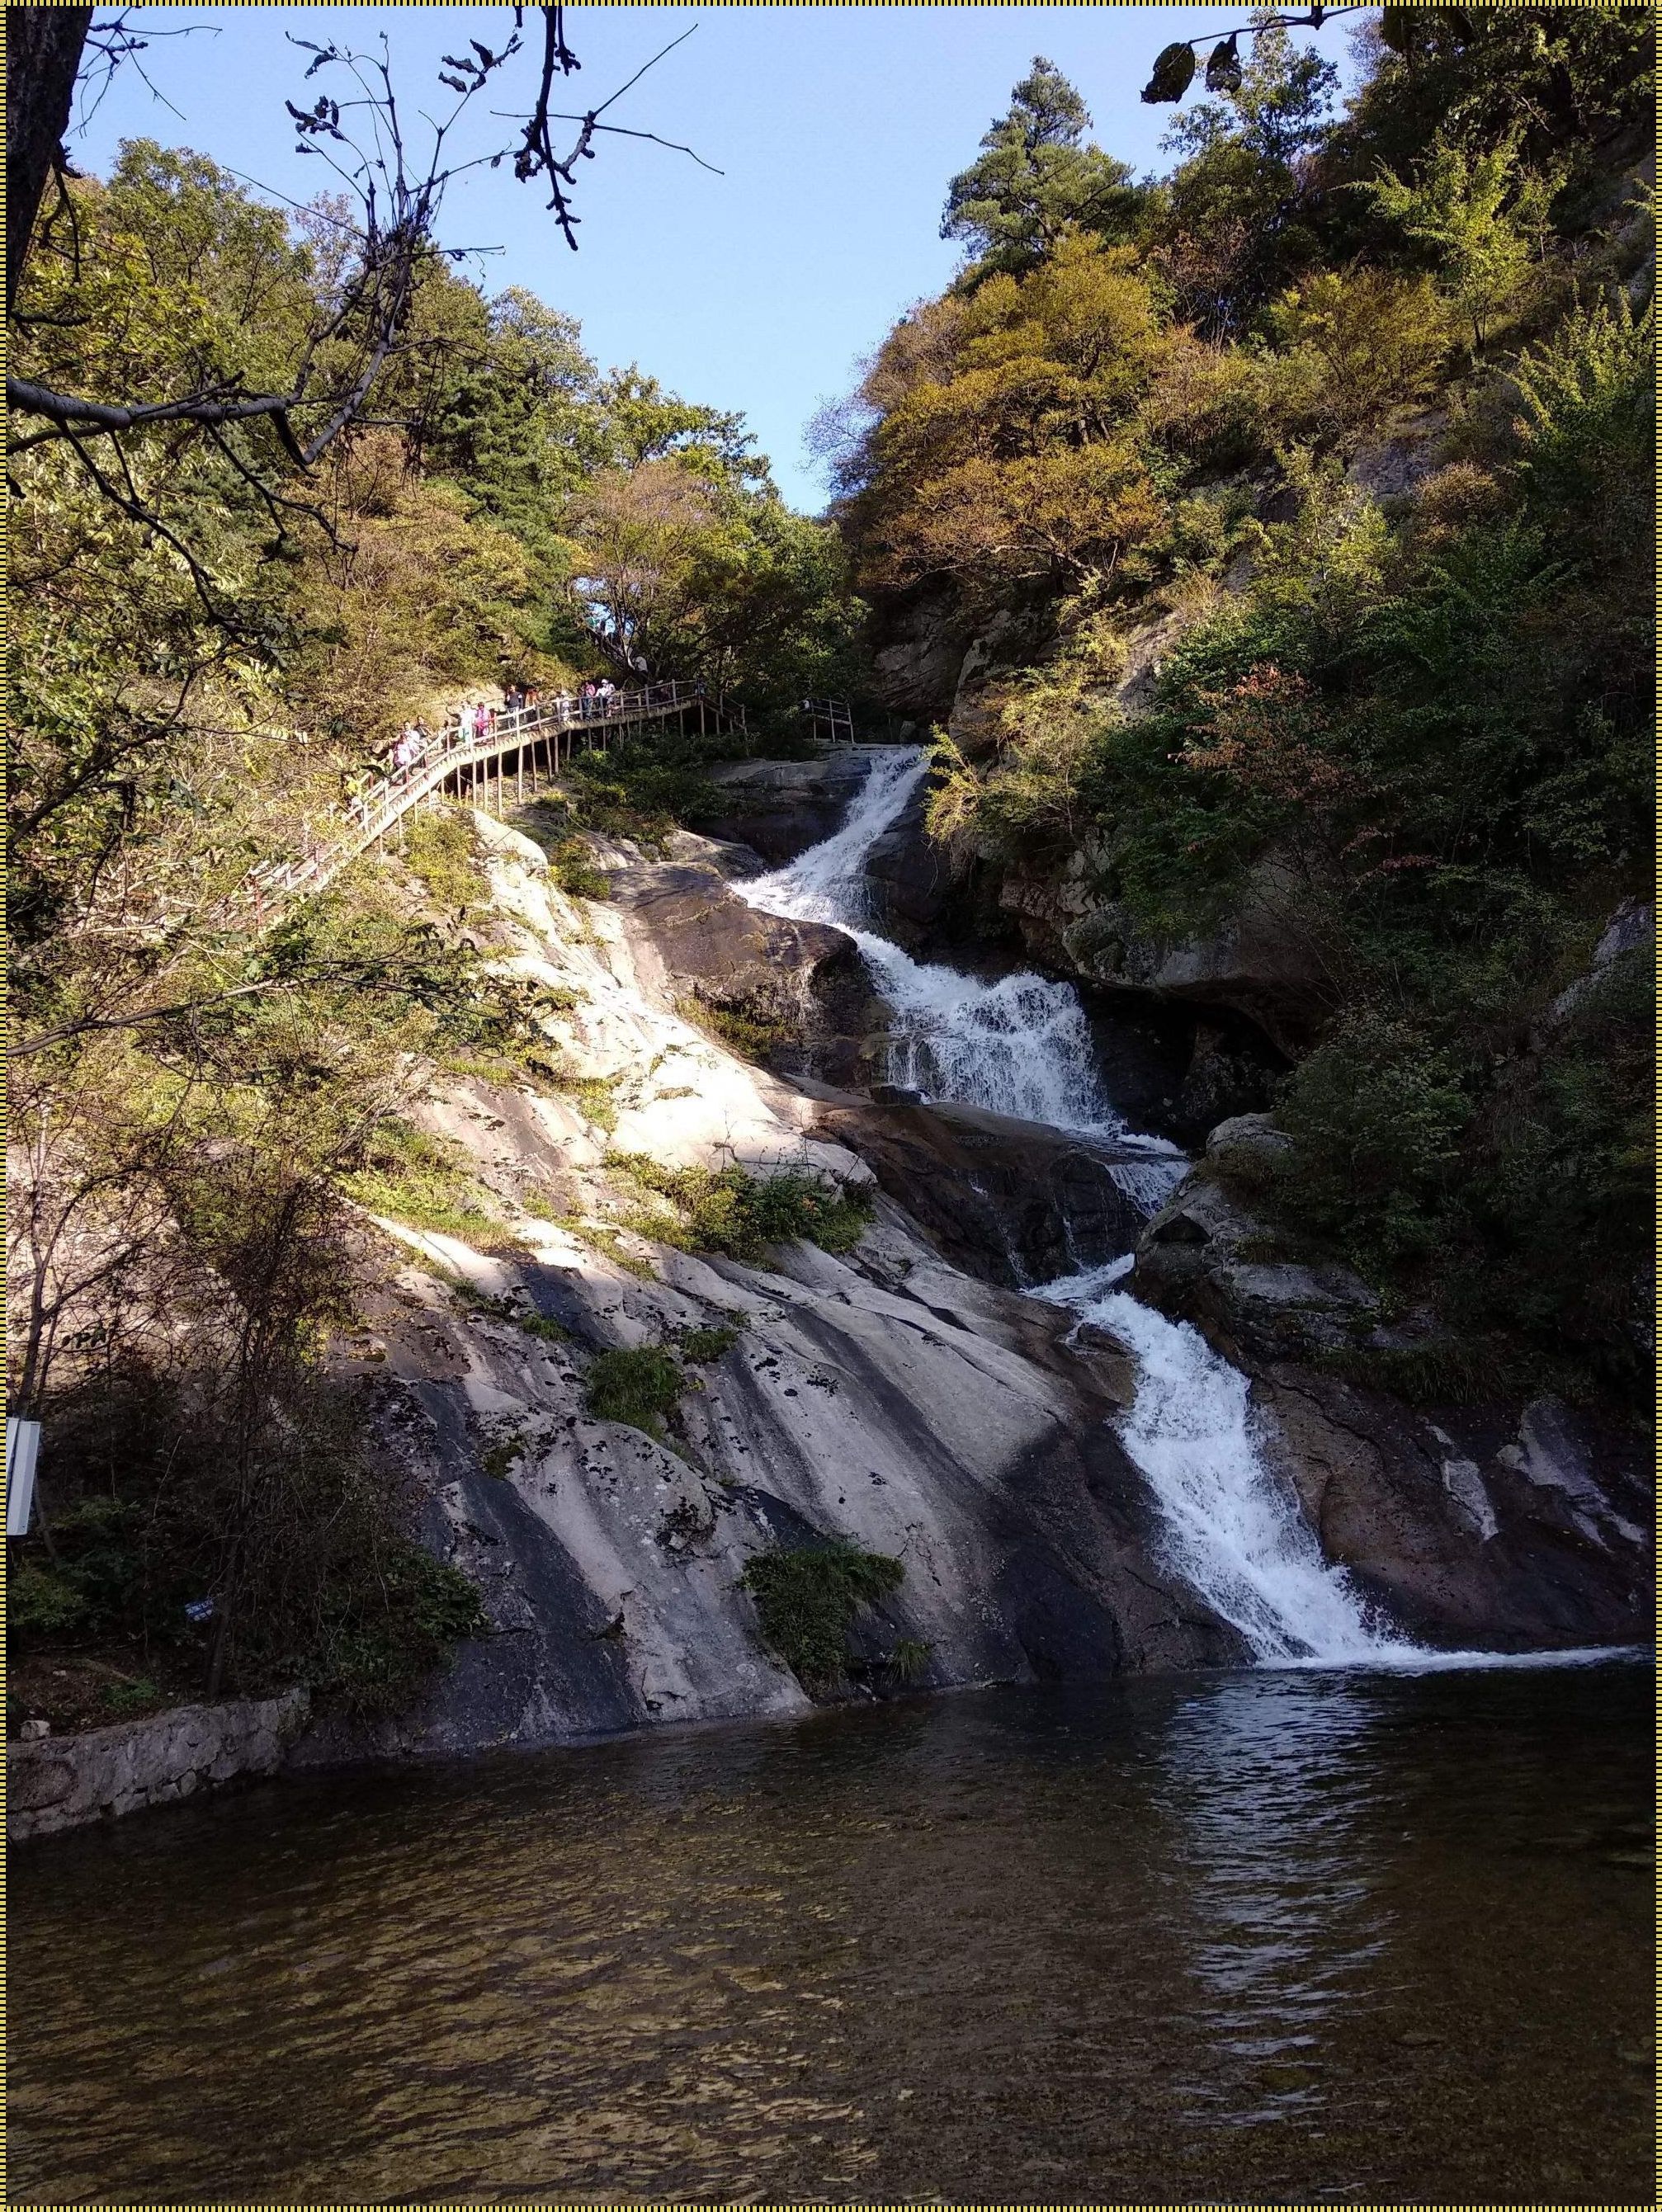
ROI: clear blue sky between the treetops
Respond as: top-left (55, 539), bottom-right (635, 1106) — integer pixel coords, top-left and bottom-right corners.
top-left (68, 7), bottom-right (1361, 509)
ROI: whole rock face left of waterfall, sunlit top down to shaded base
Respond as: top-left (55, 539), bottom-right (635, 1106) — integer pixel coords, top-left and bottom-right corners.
top-left (299, 825), bottom-right (1239, 1761)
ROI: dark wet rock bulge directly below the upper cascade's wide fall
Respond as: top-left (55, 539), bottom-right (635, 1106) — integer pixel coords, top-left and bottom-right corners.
top-left (814, 1101), bottom-right (1146, 1285)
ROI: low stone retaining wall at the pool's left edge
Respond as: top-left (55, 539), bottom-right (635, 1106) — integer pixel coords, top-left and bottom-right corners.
top-left (7, 1690), bottom-right (308, 1842)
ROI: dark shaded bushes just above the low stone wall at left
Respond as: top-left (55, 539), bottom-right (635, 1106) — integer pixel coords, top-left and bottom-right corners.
top-left (9, 1336), bottom-right (484, 1714)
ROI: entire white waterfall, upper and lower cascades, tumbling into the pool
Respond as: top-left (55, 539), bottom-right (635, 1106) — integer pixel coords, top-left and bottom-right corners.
top-left (734, 750), bottom-right (1637, 1670)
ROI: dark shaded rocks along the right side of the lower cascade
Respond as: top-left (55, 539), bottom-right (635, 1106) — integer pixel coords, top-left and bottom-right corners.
top-left (1129, 1115), bottom-right (1653, 1644)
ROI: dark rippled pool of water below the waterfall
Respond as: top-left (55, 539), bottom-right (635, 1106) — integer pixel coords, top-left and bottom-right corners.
top-left (7, 1666), bottom-right (1653, 2203)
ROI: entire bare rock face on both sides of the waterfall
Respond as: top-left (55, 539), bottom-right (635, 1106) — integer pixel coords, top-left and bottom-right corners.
top-left (296, 787), bottom-right (1646, 1761)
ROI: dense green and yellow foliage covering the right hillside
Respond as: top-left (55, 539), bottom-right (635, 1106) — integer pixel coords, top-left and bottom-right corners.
top-left (838, 26), bottom-right (1655, 1391)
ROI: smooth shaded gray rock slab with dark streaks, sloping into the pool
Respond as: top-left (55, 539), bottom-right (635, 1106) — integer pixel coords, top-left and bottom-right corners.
top-left (299, 1205), bottom-right (1241, 1761)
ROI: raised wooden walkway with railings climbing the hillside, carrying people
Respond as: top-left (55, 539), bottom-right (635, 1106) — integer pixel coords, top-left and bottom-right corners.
top-left (246, 683), bottom-right (748, 927)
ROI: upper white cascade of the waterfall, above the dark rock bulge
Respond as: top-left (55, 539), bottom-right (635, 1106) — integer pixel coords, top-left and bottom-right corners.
top-left (734, 748), bottom-right (1184, 1186)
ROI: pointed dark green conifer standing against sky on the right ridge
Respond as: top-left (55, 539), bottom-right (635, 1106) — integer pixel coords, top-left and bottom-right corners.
top-left (941, 55), bottom-right (1142, 276)
